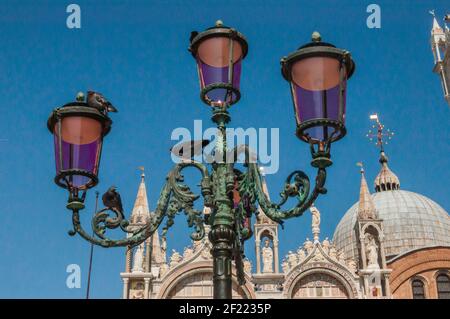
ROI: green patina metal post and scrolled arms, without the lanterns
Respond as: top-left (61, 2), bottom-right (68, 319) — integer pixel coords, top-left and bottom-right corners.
top-left (61, 106), bottom-right (331, 298)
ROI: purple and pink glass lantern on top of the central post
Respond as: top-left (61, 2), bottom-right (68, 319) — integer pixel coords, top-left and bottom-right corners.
top-left (189, 20), bottom-right (248, 106)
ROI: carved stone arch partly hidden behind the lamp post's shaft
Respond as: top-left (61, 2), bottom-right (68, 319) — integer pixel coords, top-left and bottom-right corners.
top-left (156, 261), bottom-right (256, 299)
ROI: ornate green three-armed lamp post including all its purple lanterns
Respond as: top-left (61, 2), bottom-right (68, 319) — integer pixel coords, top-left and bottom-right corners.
top-left (47, 21), bottom-right (354, 298)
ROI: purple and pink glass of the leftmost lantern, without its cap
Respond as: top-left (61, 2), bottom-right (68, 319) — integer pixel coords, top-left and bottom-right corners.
top-left (54, 116), bottom-right (102, 189)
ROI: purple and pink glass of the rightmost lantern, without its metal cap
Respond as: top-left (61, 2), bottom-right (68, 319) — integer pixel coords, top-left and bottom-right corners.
top-left (291, 57), bottom-right (346, 141)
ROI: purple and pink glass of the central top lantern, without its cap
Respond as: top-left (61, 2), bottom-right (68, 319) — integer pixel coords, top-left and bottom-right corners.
top-left (197, 37), bottom-right (242, 103)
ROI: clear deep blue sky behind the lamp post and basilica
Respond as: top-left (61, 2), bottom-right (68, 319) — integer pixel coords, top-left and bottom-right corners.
top-left (0, 0), bottom-right (450, 298)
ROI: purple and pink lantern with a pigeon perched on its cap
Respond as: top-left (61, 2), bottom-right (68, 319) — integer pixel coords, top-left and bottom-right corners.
top-left (47, 102), bottom-right (112, 192)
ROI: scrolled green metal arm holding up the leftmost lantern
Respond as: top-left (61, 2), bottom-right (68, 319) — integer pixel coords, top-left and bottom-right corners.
top-left (68, 161), bottom-right (212, 247)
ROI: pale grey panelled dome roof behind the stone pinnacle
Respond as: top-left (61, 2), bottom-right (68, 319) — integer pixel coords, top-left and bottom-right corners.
top-left (333, 190), bottom-right (450, 258)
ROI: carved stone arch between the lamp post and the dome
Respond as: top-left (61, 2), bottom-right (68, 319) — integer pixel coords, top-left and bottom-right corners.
top-left (283, 262), bottom-right (359, 299)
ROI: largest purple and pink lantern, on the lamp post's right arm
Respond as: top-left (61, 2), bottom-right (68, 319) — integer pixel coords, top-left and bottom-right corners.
top-left (281, 32), bottom-right (355, 146)
